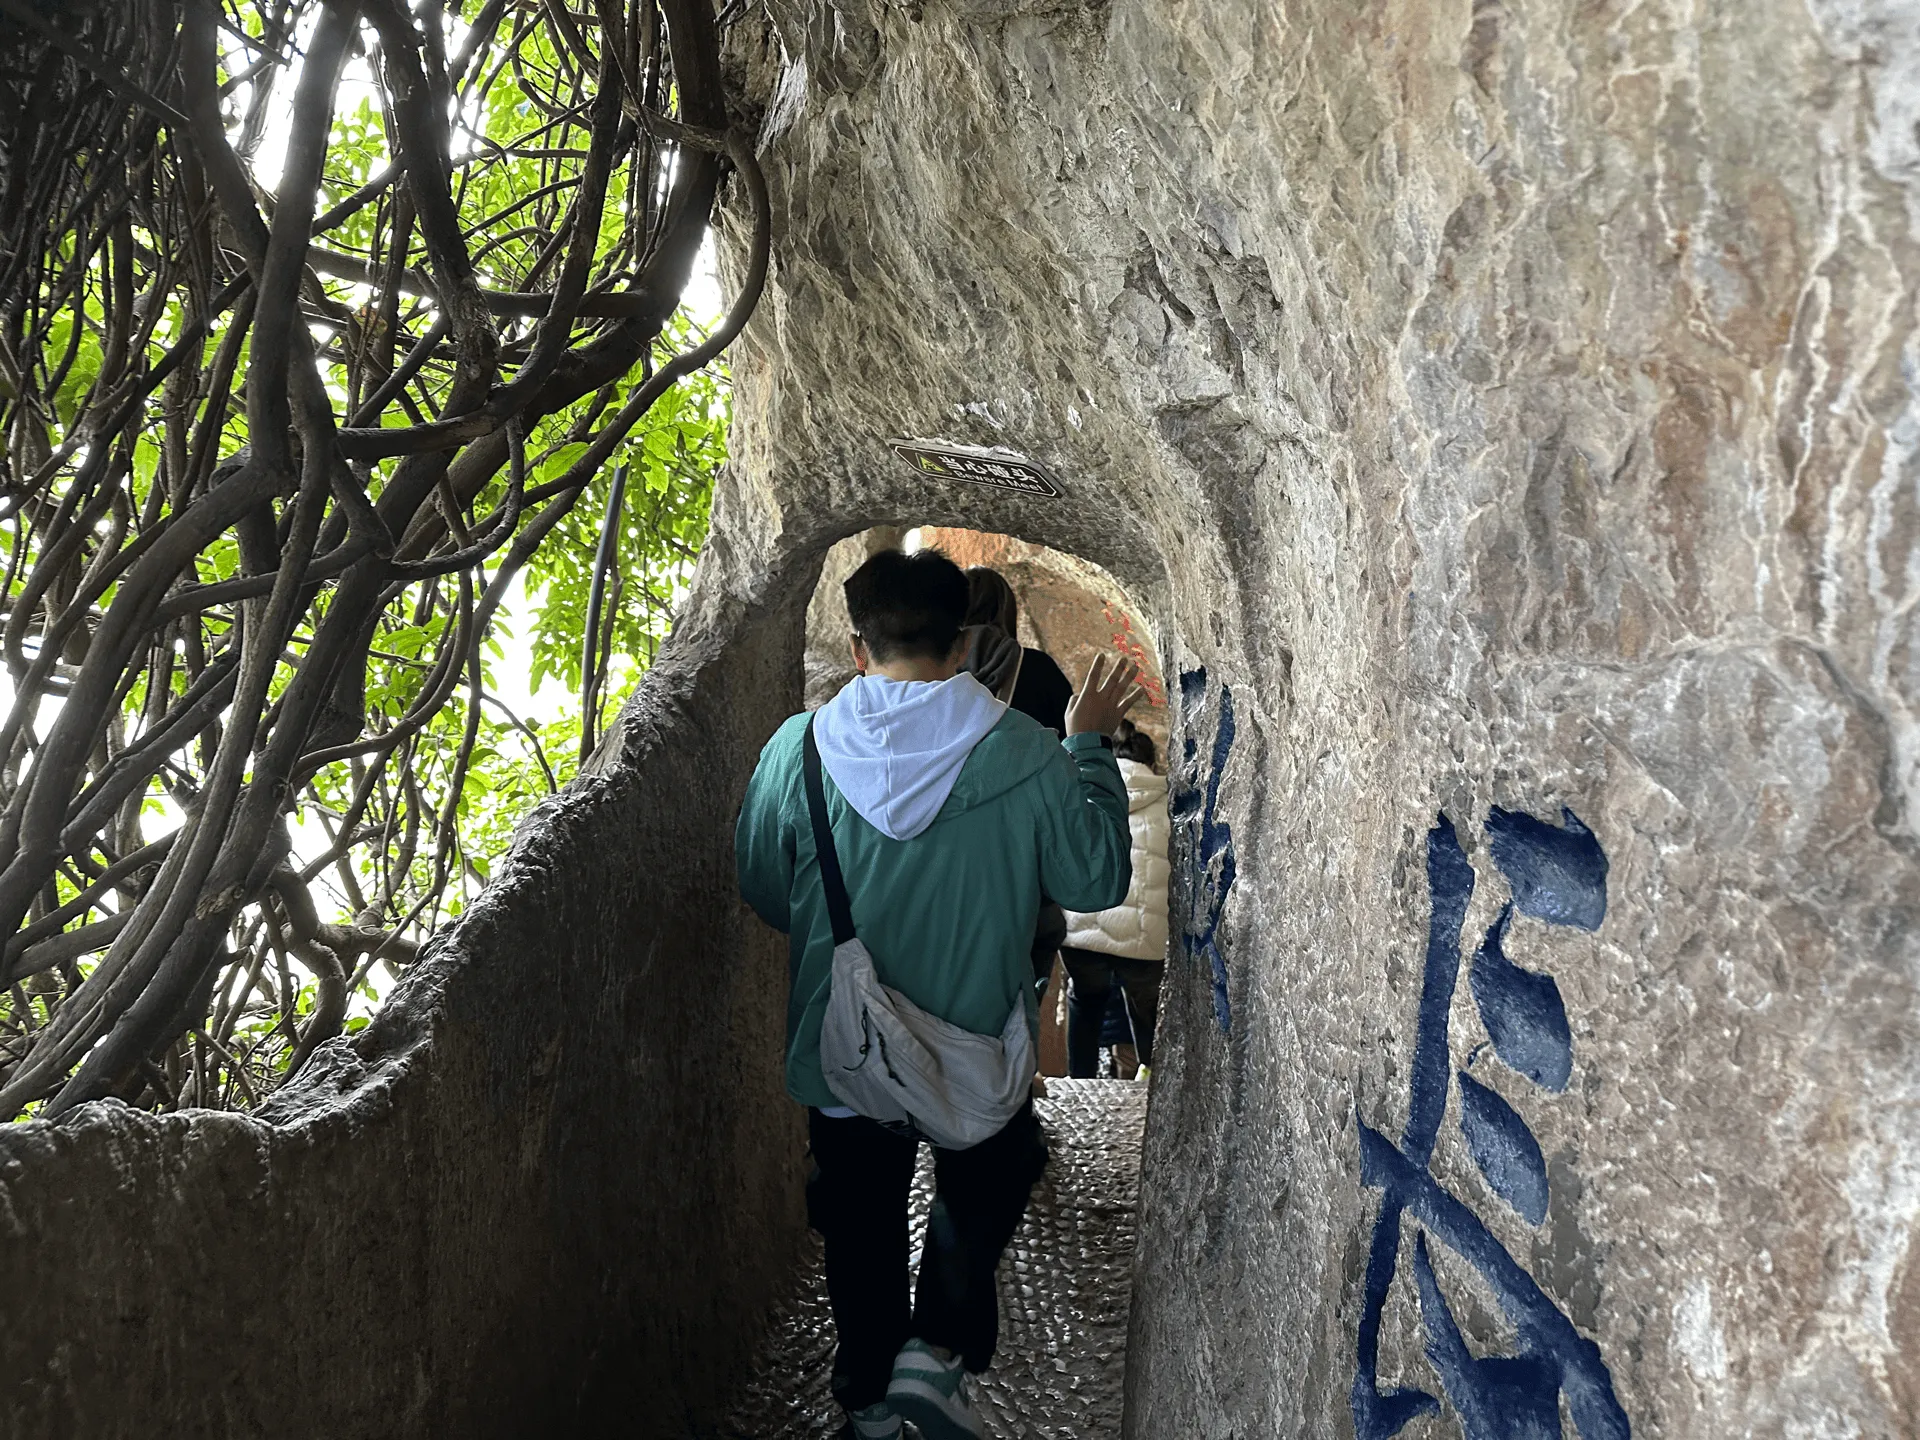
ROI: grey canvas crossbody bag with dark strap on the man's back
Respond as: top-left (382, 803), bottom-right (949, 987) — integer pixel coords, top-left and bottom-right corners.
top-left (804, 720), bottom-right (1033, 1150)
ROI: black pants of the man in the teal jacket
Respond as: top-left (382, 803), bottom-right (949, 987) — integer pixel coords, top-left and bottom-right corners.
top-left (806, 1104), bottom-right (1046, 1409)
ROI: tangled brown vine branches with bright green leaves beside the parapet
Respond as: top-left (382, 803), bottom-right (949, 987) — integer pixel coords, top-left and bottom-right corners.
top-left (0, 0), bottom-right (766, 1117)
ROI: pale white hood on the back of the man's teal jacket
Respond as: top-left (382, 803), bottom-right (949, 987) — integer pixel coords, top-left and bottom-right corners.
top-left (814, 672), bottom-right (1006, 839)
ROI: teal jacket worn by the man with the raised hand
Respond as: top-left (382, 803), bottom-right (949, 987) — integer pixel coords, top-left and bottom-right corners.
top-left (733, 695), bottom-right (1133, 1108)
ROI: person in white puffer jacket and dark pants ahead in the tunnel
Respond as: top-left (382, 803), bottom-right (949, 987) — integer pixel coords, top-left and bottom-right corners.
top-left (1060, 722), bottom-right (1173, 1079)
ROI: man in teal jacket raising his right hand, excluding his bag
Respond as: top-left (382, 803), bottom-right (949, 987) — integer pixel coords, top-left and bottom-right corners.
top-left (735, 551), bottom-right (1140, 1440)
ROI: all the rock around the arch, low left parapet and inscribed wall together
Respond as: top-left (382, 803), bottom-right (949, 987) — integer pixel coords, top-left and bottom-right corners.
top-left (0, 0), bottom-right (1920, 1440)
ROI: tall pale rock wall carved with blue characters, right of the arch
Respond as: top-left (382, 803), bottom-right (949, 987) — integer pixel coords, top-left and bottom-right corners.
top-left (733, 0), bottom-right (1920, 1440)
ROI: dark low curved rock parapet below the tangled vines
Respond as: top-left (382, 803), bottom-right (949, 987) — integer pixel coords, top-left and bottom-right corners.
top-left (0, 545), bottom-right (810, 1440)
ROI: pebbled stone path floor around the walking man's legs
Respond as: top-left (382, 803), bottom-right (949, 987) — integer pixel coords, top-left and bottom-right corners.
top-left (726, 1079), bottom-right (1146, 1440)
